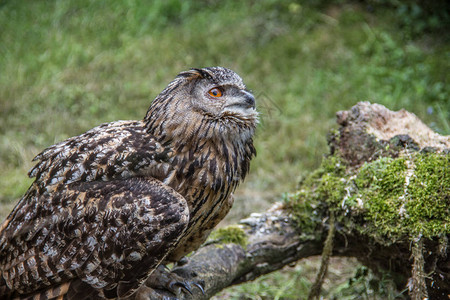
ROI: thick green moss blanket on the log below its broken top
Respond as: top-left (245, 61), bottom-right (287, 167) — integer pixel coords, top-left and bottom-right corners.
top-left (286, 153), bottom-right (450, 242)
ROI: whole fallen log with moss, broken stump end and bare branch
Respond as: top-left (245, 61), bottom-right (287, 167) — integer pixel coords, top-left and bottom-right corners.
top-left (139, 102), bottom-right (450, 299)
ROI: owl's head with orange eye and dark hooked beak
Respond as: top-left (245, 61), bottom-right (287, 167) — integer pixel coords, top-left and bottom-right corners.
top-left (145, 67), bottom-right (258, 142)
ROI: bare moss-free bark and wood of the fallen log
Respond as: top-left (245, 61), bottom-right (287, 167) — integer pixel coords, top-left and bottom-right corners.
top-left (149, 102), bottom-right (450, 299)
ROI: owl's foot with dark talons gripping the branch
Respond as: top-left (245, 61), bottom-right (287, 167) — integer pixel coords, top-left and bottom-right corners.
top-left (135, 265), bottom-right (205, 300)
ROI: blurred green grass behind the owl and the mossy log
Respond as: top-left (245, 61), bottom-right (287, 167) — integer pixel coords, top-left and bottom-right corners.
top-left (0, 0), bottom-right (450, 299)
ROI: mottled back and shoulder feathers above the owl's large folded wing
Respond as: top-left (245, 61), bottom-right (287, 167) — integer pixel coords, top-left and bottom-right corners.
top-left (29, 121), bottom-right (172, 191)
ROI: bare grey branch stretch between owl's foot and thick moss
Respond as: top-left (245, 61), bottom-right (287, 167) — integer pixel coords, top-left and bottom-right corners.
top-left (173, 210), bottom-right (323, 299)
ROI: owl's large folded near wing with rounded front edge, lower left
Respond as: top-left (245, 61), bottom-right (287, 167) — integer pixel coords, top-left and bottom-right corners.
top-left (0, 178), bottom-right (189, 299)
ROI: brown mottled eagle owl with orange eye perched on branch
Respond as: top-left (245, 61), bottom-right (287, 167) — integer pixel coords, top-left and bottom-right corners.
top-left (0, 67), bottom-right (258, 300)
